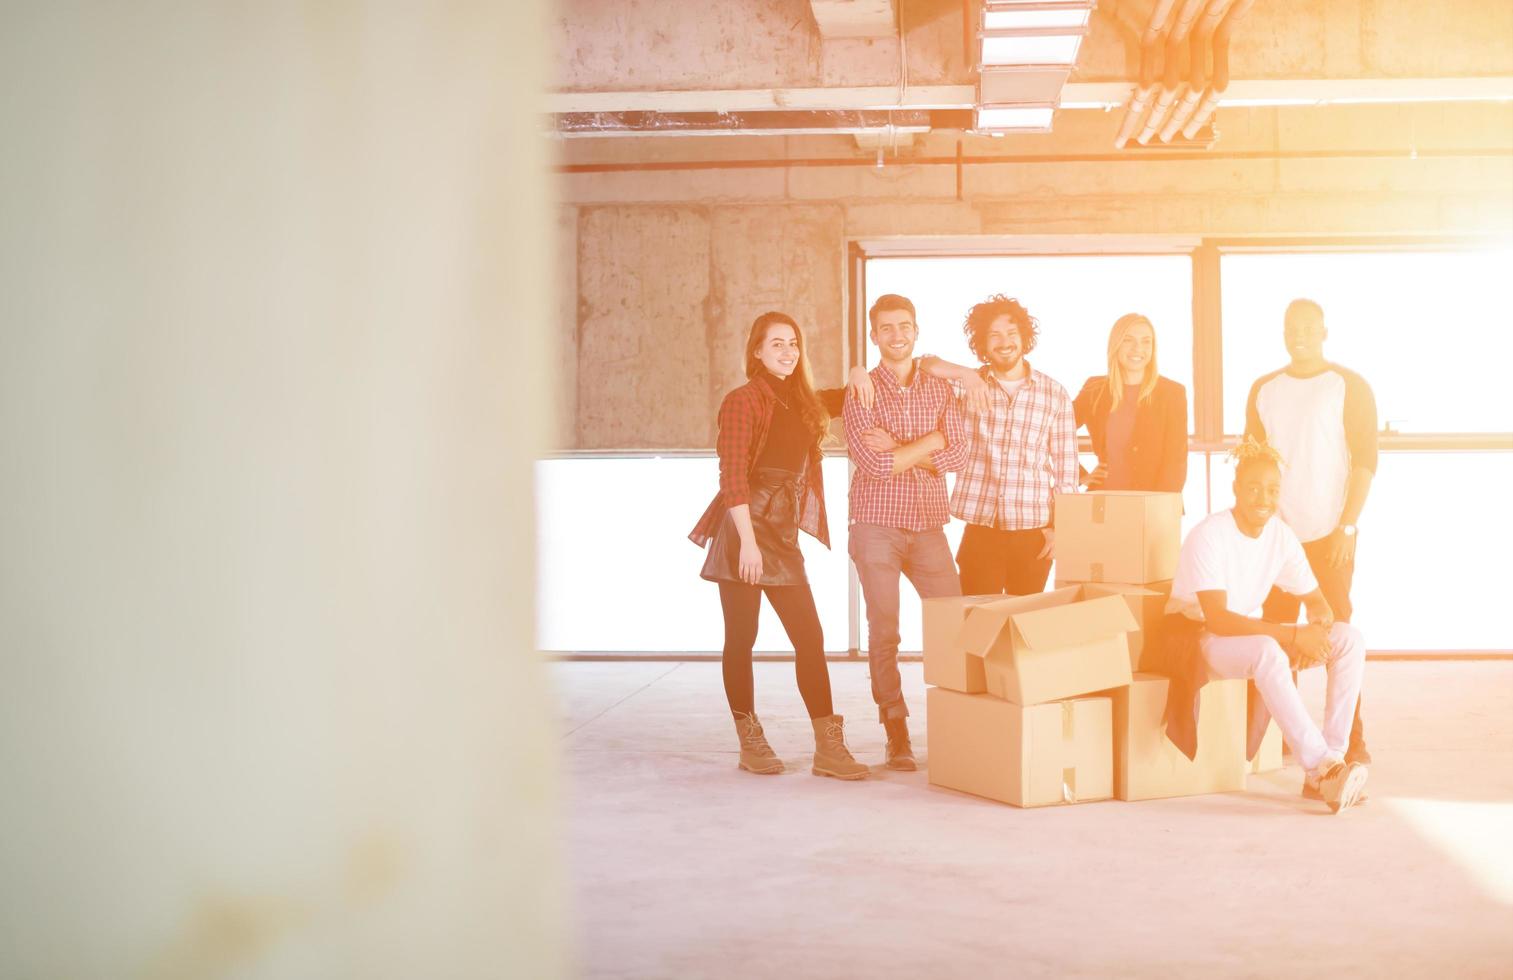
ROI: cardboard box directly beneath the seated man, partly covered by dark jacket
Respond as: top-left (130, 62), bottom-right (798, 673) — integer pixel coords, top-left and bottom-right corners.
top-left (1109, 673), bottom-right (1250, 800)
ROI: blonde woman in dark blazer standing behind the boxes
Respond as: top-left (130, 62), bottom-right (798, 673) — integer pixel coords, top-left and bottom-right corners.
top-left (1073, 313), bottom-right (1188, 493)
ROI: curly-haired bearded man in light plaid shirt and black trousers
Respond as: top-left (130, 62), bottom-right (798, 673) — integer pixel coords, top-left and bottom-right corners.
top-left (926, 295), bottom-right (1079, 596)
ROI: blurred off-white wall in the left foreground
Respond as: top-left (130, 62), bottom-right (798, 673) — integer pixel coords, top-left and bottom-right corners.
top-left (0, 0), bottom-right (567, 977)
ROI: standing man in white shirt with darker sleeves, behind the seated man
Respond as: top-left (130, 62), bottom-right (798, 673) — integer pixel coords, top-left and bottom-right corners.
top-left (1245, 299), bottom-right (1377, 765)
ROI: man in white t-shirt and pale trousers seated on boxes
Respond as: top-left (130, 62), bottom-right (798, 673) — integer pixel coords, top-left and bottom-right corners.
top-left (1167, 440), bottom-right (1366, 814)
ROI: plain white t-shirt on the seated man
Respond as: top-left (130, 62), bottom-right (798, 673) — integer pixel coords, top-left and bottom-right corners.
top-left (1167, 510), bottom-right (1319, 620)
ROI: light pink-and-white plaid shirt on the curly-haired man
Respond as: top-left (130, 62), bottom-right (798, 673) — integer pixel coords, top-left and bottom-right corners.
top-left (950, 361), bottom-right (1077, 531)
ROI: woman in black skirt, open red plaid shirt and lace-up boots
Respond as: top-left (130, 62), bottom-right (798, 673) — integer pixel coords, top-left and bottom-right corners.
top-left (688, 313), bottom-right (867, 779)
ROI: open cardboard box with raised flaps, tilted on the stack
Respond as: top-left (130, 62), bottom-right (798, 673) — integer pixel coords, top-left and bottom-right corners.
top-left (961, 585), bottom-right (1136, 705)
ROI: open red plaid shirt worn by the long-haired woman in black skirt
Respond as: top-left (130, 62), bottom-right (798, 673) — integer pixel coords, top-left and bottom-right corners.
top-left (688, 377), bottom-right (831, 547)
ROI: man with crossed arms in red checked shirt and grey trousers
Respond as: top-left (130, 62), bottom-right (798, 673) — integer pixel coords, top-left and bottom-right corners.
top-left (843, 293), bottom-right (967, 771)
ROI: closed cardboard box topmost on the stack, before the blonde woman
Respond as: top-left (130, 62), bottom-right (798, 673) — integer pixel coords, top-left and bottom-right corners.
top-left (1056, 490), bottom-right (1182, 585)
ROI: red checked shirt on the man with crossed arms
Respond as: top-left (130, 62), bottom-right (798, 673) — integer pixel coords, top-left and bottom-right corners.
top-left (841, 358), bottom-right (967, 531)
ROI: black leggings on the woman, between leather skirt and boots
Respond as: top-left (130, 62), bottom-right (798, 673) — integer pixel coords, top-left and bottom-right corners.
top-left (720, 582), bottom-right (835, 718)
